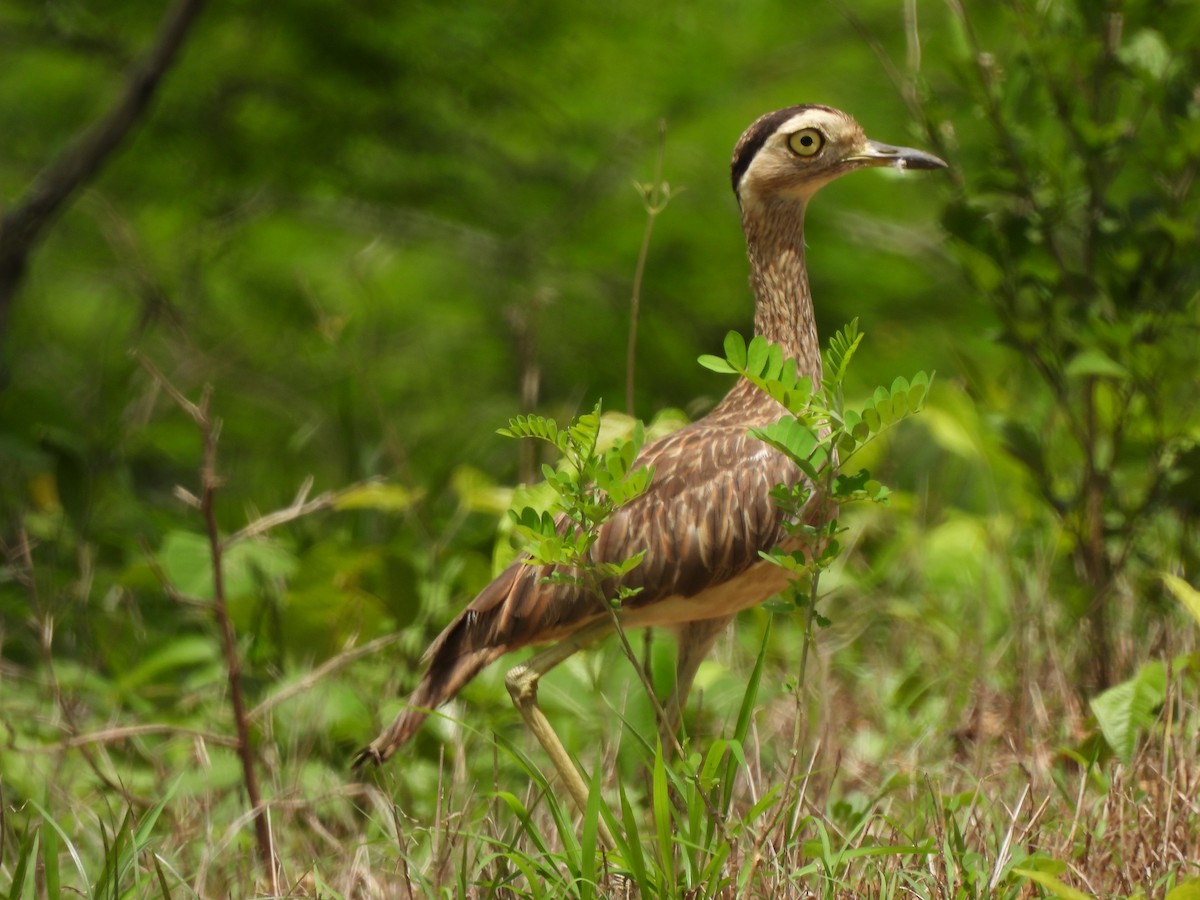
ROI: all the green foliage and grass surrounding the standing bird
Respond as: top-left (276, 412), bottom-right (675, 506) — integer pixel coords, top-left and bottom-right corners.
top-left (0, 0), bottom-right (1200, 900)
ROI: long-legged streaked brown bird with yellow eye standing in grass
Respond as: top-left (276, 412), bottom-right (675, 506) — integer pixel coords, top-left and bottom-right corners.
top-left (354, 104), bottom-right (946, 825)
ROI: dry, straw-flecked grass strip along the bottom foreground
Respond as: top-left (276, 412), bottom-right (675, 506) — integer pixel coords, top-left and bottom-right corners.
top-left (0, 609), bottom-right (1200, 898)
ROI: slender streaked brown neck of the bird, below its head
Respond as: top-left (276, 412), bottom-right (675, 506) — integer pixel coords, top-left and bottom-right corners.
top-left (742, 199), bottom-right (821, 384)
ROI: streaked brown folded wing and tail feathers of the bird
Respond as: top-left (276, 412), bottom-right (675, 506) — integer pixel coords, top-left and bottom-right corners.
top-left (355, 383), bottom-right (799, 764)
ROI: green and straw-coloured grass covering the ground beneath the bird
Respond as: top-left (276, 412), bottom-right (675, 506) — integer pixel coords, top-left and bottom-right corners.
top-left (0, 578), bottom-right (1200, 900)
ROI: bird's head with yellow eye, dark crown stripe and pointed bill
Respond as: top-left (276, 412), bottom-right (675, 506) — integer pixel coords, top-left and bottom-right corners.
top-left (732, 106), bottom-right (946, 209)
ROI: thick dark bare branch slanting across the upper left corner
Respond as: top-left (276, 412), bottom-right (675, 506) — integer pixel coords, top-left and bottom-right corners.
top-left (0, 0), bottom-right (205, 338)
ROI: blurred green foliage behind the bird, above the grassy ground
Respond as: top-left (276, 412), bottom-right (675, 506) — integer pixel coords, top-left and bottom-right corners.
top-left (0, 0), bottom-right (1200, 897)
